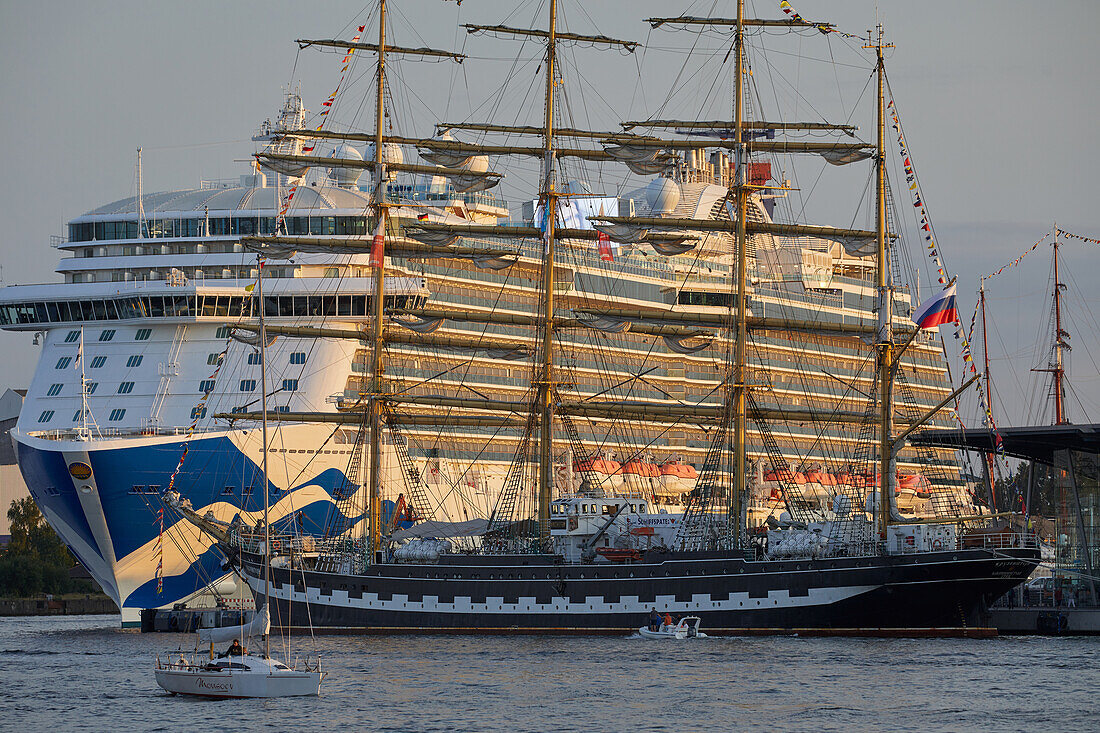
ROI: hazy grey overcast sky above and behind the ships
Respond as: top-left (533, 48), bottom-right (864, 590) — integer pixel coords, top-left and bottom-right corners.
top-left (0, 0), bottom-right (1100, 425)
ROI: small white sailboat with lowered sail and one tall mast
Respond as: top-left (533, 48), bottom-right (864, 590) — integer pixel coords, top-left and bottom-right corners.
top-left (155, 217), bottom-right (325, 698)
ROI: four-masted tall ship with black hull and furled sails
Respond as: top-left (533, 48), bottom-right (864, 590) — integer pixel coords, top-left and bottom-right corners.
top-left (176, 0), bottom-right (1038, 633)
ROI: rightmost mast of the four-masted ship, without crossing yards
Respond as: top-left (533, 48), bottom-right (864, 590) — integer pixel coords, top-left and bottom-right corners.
top-left (873, 24), bottom-right (894, 539)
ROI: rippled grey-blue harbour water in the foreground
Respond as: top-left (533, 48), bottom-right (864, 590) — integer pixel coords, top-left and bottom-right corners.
top-left (0, 616), bottom-right (1100, 733)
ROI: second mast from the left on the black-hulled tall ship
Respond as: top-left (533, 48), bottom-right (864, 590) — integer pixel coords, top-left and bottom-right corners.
top-left (538, 0), bottom-right (558, 543)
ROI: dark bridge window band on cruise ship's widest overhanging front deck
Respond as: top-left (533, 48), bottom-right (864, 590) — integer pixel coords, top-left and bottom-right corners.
top-left (0, 295), bottom-right (425, 323)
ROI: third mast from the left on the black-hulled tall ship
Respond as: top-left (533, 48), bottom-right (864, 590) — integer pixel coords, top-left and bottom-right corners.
top-left (730, 0), bottom-right (748, 547)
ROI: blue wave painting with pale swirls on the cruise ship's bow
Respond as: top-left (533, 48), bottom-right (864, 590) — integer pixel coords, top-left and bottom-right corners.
top-left (15, 435), bottom-right (362, 620)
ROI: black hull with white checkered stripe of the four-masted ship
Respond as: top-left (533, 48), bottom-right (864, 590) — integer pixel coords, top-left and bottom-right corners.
top-left (237, 548), bottom-right (1040, 634)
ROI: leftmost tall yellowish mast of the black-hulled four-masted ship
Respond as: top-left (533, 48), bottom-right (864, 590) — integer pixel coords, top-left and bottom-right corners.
top-left (367, 0), bottom-right (386, 562)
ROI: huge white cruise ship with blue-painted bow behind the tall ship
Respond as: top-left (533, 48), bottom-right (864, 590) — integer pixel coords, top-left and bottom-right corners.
top-left (0, 95), bottom-right (972, 625)
